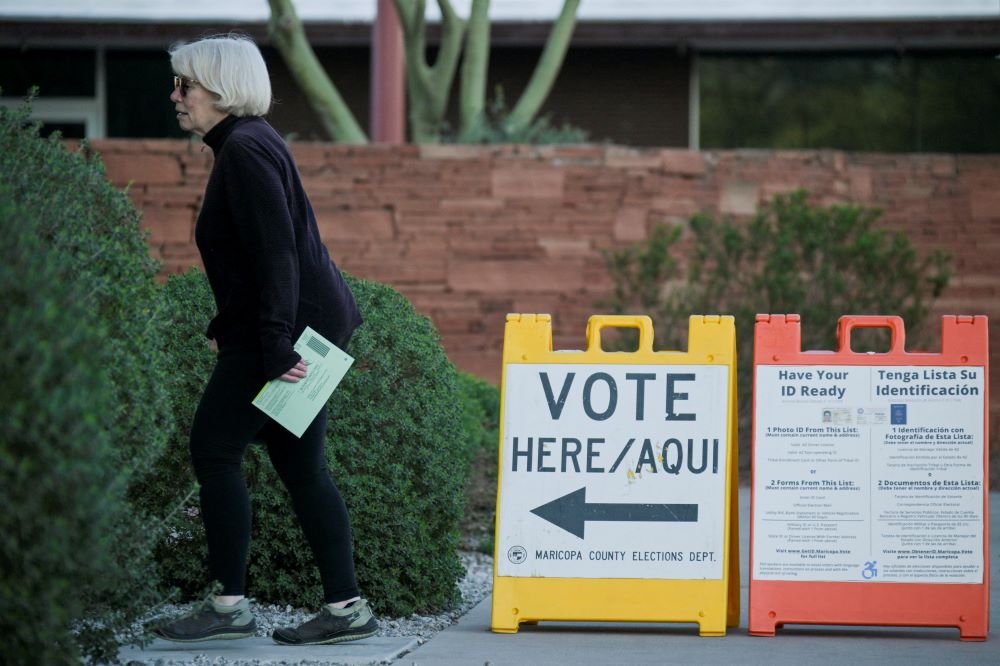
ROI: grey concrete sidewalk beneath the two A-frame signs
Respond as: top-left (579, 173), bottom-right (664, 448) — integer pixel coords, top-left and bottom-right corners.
top-left (396, 488), bottom-right (1000, 666)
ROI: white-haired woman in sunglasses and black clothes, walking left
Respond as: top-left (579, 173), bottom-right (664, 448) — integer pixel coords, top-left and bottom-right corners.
top-left (156, 36), bottom-right (378, 645)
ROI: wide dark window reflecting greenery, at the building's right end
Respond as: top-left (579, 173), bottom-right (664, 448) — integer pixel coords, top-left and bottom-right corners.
top-left (699, 51), bottom-right (1000, 153)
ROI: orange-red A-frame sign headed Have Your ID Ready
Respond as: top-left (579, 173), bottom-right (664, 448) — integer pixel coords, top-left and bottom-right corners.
top-left (749, 315), bottom-right (989, 641)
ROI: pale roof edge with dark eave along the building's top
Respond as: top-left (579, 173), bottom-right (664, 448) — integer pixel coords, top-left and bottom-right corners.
top-left (0, 0), bottom-right (1000, 51)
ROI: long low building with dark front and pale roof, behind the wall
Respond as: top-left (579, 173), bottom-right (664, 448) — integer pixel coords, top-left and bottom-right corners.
top-left (0, 0), bottom-right (1000, 152)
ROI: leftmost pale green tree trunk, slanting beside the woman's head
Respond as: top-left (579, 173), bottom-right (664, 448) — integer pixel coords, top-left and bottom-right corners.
top-left (267, 0), bottom-right (368, 143)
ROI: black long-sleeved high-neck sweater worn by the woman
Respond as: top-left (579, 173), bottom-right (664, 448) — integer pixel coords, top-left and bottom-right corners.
top-left (195, 116), bottom-right (361, 379)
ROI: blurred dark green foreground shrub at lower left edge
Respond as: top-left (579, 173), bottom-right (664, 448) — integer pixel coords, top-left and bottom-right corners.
top-left (0, 187), bottom-right (115, 664)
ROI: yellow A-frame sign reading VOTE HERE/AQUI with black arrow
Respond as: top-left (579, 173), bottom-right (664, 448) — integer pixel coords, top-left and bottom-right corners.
top-left (492, 314), bottom-right (739, 636)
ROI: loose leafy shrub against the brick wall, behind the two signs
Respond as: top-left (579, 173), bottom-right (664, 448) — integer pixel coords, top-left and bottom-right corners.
top-left (604, 190), bottom-right (950, 469)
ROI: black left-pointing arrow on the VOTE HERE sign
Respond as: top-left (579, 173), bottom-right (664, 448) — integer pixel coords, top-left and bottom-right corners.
top-left (531, 487), bottom-right (698, 539)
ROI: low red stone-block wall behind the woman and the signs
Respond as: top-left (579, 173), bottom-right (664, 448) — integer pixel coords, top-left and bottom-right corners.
top-left (94, 141), bottom-right (1000, 434)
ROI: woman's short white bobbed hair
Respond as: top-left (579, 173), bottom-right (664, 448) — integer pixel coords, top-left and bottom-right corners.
top-left (170, 34), bottom-right (271, 117)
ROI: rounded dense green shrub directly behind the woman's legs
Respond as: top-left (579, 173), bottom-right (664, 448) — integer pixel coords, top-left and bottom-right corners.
top-left (158, 272), bottom-right (482, 615)
